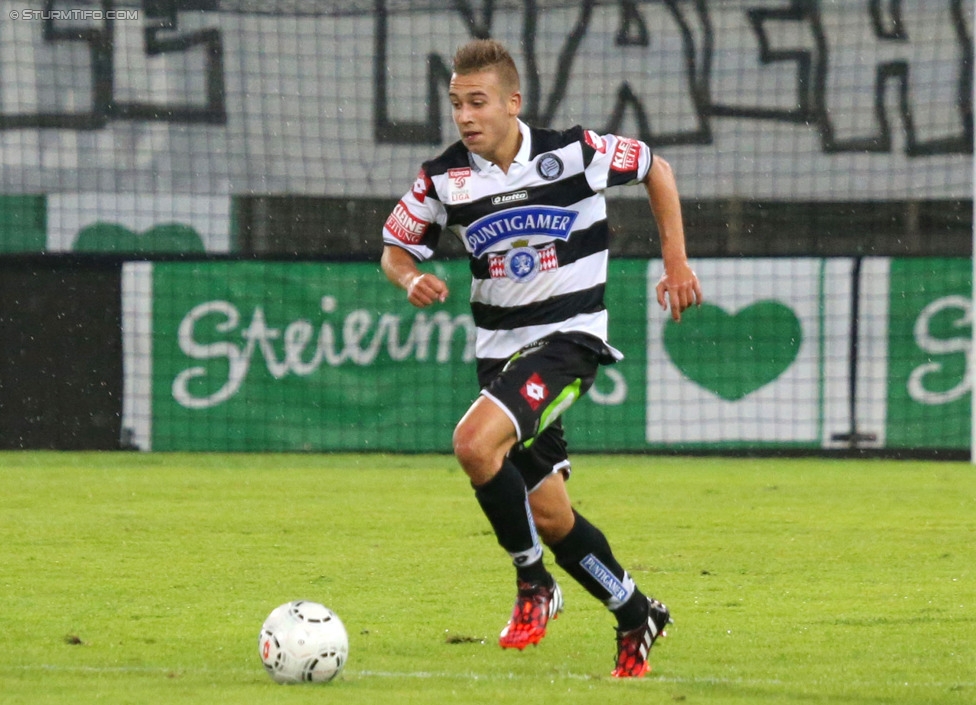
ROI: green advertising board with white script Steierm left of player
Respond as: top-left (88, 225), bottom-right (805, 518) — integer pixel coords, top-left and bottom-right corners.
top-left (152, 262), bottom-right (476, 451)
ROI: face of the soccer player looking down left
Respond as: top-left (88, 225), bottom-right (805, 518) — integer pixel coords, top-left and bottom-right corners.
top-left (449, 69), bottom-right (522, 166)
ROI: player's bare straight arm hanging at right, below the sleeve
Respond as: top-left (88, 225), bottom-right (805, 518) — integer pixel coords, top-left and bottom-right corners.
top-left (642, 155), bottom-right (704, 321)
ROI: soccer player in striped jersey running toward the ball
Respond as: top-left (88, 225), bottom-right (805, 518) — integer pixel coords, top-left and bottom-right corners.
top-left (382, 39), bottom-right (702, 678)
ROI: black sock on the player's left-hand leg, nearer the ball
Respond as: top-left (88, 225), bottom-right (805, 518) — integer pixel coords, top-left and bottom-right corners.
top-left (474, 458), bottom-right (551, 583)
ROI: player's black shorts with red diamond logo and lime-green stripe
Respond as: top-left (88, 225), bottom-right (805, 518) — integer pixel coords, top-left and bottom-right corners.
top-left (478, 336), bottom-right (601, 492)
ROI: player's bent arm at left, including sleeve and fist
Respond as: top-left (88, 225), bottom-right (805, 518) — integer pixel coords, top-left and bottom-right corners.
top-left (380, 168), bottom-right (449, 308)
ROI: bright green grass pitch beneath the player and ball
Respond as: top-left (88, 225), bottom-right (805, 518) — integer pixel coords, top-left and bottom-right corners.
top-left (0, 453), bottom-right (976, 705)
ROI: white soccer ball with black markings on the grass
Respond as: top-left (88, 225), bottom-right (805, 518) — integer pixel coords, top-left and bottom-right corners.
top-left (258, 600), bottom-right (349, 683)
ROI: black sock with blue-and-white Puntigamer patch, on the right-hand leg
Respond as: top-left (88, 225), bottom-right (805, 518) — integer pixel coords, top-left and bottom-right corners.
top-left (550, 510), bottom-right (648, 631)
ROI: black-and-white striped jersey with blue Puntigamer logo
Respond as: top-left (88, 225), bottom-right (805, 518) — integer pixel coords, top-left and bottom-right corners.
top-left (383, 121), bottom-right (653, 359)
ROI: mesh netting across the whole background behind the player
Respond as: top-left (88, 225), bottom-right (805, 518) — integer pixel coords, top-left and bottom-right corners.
top-left (0, 0), bottom-right (974, 450)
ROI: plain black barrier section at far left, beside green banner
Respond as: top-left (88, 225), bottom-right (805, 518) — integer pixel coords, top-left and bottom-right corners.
top-left (0, 258), bottom-right (123, 450)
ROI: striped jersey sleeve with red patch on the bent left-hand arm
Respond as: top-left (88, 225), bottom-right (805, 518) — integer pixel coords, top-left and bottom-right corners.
top-left (383, 167), bottom-right (447, 261)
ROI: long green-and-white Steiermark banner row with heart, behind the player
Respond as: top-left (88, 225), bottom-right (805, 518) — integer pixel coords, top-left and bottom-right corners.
top-left (123, 258), bottom-right (972, 451)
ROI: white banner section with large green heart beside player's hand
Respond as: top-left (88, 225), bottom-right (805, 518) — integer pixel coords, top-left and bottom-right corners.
top-left (646, 259), bottom-right (851, 447)
